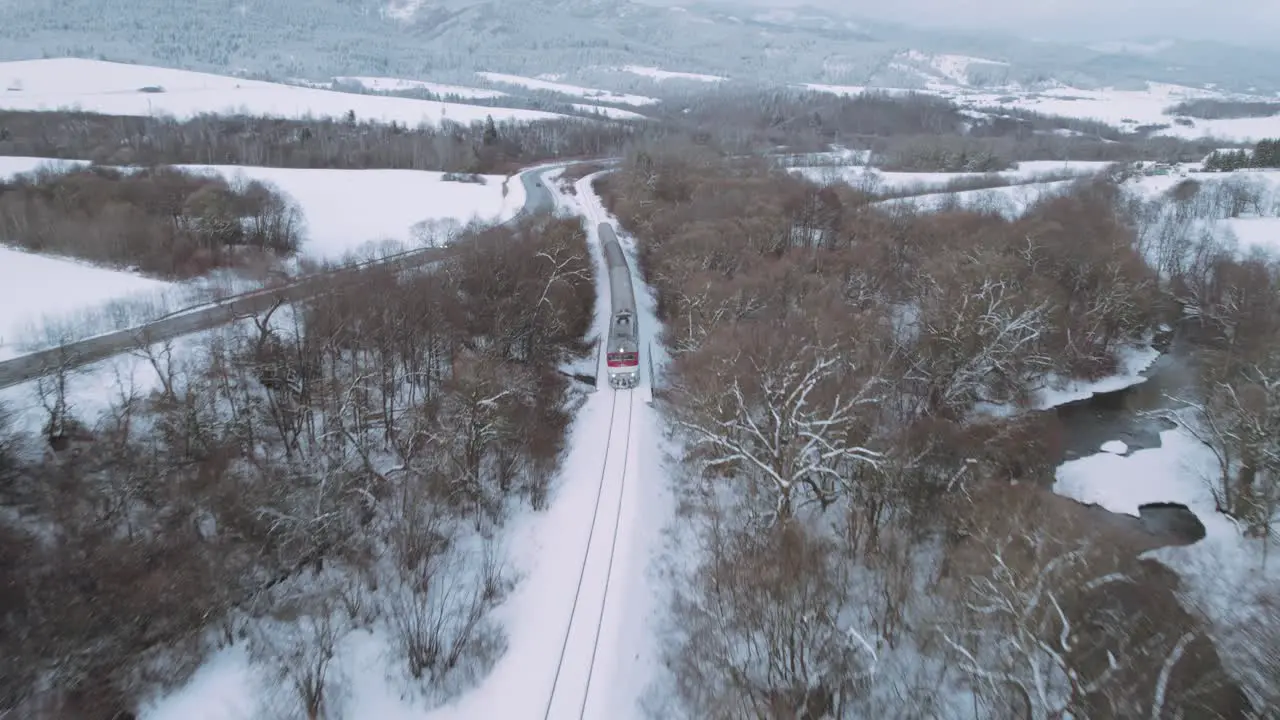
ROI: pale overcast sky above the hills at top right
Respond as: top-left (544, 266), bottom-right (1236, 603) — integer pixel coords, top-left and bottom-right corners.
top-left (727, 0), bottom-right (1280, 42)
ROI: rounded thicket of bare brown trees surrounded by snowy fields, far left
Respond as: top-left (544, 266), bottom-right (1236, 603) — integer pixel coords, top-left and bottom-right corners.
top-left (0, 167), bottom-right (303, 278)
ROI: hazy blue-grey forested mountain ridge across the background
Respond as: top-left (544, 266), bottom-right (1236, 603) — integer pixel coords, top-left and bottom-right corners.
top-left (0, 0), bottom-right (1280, 94)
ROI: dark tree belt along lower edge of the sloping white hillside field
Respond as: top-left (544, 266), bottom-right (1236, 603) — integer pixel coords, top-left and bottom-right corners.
top-left (0, 111), bottom-right (654, 173)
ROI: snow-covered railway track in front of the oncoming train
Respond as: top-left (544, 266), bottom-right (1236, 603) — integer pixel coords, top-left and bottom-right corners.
top-left (543, 391), bottom-right (635, 720)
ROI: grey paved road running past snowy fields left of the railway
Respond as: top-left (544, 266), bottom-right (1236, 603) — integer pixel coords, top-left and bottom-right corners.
top-left (0, 167), bottom-right (556, 388)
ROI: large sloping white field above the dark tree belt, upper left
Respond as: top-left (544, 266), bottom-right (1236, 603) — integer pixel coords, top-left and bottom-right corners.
top-left (0, 58), bottom-right (564, 127)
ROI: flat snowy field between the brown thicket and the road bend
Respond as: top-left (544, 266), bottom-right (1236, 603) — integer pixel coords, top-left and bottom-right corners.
top-left (171, 165), bottom-right (525, 260)
